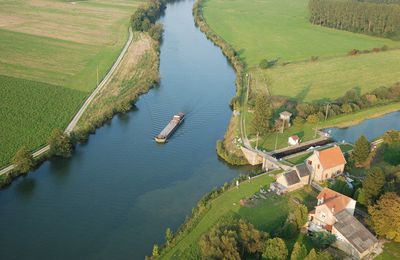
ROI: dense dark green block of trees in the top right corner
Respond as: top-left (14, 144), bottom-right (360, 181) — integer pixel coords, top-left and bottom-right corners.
top-left (309, 0), bottom-right (400, 37)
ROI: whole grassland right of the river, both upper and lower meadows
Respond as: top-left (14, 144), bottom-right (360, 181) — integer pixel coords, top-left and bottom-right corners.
top-left (204, 0), bottom-right (400, 102)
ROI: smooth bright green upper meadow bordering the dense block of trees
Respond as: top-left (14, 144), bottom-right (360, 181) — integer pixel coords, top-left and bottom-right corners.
top-left (204, 0), bottom-right (400, 67)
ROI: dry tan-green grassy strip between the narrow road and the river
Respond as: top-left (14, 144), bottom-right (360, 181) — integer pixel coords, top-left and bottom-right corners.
top-left (73, 32), bottom-right (159, 139)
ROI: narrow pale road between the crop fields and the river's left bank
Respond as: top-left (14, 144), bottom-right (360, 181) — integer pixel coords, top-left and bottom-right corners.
top-left (0, 27), bottom-right (133, 176)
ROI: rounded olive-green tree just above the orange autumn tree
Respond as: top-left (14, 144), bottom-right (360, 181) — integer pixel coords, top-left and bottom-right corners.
top-left (363, 167), bottom-right (385, 203)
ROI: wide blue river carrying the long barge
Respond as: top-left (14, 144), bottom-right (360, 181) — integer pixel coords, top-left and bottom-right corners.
top-left (0, 1), bottom-right (250, 259)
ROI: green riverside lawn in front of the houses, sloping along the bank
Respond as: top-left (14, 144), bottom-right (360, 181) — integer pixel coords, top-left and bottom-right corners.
top-left (161, 175), bottom-right (316, 259)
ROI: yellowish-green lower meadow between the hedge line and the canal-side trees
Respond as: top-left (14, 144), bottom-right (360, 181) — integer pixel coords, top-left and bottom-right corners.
top-left (251, 50), bottom-right (400, 102)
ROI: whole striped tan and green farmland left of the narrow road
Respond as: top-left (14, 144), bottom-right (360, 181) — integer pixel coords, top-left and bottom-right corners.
top-left (0, 0), bottom-right (143, 166)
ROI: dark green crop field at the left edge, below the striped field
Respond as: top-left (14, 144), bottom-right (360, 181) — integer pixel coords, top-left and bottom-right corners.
top-left (0, 75), bottom-right (86, 165)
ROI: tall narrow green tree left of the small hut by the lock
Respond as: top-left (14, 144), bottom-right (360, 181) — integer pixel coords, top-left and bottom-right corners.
top-left (253, 94), bottom-right (272, 134)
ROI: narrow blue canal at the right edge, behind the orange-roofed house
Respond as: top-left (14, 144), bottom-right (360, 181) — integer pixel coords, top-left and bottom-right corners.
top-left (326, 111), bottom-right (400, 143)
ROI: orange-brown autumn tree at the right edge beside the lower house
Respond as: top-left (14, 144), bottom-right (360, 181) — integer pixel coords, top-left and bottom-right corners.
top-left (368, 192), bottom-right (400, 242)
